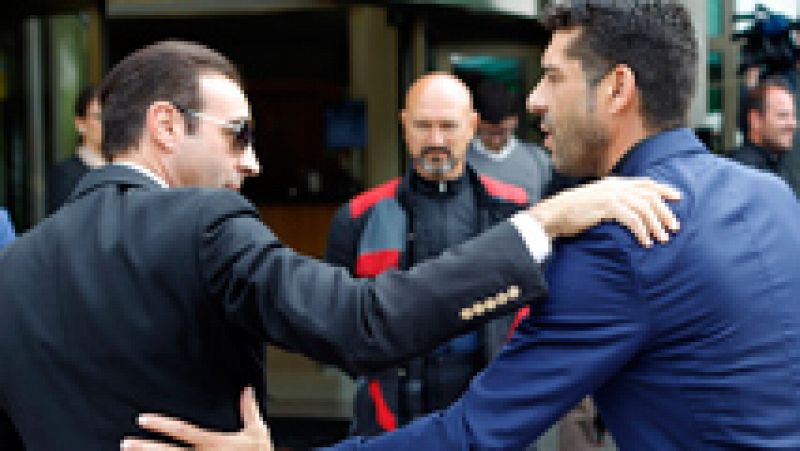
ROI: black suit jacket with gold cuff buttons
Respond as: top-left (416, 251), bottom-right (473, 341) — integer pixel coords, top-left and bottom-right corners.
top-left (0, 166), bottom-right (544, 450)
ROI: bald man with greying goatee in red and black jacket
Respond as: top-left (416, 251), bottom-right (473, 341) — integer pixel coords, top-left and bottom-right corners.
top-left (325, 73), bottom-right (533, 435)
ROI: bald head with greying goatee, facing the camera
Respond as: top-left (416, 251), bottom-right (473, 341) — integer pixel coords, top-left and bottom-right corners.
top-left (401, 72), bottom-right (478, 180)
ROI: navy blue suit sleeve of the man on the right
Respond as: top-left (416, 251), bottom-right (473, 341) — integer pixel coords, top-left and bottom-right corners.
top-left (324, 228), bottom-right (647, 451)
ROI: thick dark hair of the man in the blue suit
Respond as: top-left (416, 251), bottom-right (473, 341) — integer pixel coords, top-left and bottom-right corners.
top-left (544, 0), bottom-right (698, 129)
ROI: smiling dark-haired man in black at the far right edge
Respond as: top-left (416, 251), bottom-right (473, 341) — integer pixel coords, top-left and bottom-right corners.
top-left (729, 76), bottom-right (800, 195)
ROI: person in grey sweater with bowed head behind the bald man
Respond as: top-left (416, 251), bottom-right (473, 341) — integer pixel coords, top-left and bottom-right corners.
top-left (467, 80), bottom-right (552, 203)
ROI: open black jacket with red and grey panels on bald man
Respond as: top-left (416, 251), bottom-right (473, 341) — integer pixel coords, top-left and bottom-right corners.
top-left (326, 167), bottom-right (528, 435)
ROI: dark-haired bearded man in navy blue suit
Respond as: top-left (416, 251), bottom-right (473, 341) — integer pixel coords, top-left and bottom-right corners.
top-left (134, 0), bottom-right (800, 451)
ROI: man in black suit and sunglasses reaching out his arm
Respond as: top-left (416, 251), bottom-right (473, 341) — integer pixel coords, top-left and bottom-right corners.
top-left (0, 41), bottom-right (674, 450)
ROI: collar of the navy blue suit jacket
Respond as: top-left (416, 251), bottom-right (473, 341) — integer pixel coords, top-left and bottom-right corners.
top-left (611, 128), bottom-right (708, 176)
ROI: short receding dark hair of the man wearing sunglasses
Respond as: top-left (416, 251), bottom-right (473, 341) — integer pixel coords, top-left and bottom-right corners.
top-left (100, 40), bottom-right (241, 160)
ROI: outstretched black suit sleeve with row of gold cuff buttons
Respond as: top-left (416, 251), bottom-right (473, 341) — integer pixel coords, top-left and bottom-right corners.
top-left (198, 192), bottom-right (545, 373)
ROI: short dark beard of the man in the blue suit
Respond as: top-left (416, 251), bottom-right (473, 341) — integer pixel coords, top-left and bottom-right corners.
top-left (543, 111), bottom-right (611, 177)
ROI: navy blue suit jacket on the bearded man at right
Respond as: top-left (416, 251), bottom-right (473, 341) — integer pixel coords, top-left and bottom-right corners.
top-left (330, 129), bottom-right (800, 450)
